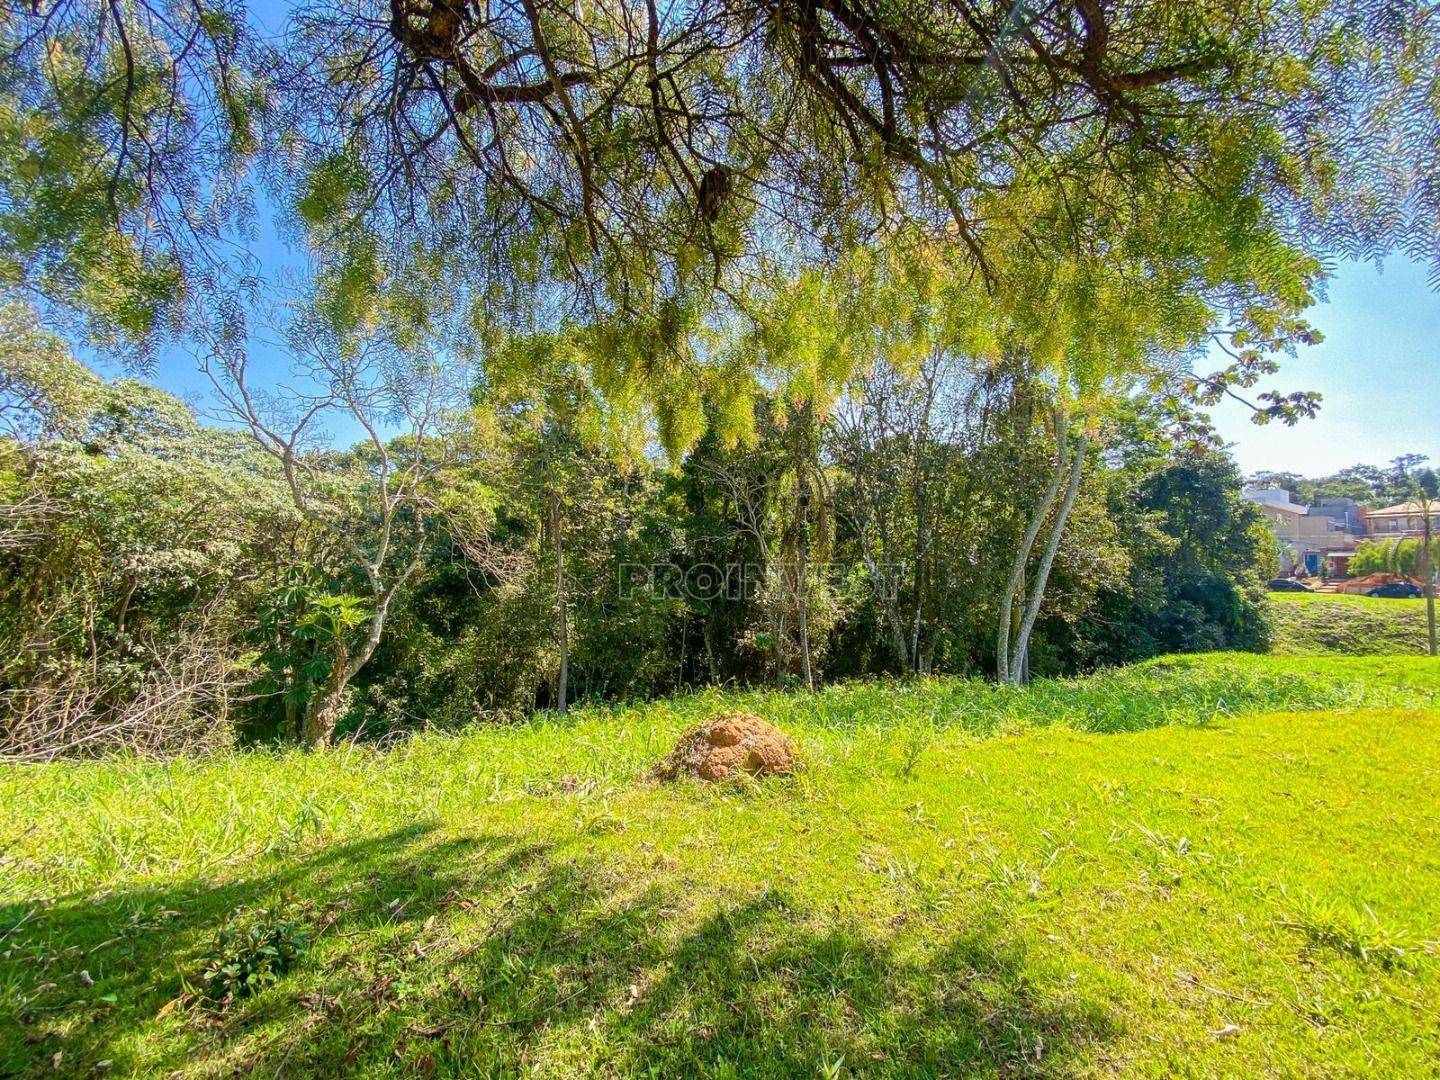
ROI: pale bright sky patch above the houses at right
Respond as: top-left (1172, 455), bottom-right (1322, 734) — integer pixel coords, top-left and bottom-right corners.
top-left (1214, 259), bottom-right (1440, 477)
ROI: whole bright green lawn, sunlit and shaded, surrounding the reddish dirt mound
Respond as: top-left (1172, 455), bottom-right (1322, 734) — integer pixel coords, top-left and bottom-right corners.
top-left (0, 657), bottom-right (1440, 1077)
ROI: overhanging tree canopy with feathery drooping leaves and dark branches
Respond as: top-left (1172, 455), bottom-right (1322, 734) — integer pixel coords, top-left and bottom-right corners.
top-left (0, 0), bottom-right (1440, 432)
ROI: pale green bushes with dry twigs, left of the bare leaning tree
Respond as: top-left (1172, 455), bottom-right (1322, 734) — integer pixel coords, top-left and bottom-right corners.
top-left (0, 308), bottom-right (298, 753)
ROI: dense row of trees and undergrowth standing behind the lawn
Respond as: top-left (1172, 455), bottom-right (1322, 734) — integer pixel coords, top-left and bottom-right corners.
top-left (0, 308), bottom-right (1273, 759)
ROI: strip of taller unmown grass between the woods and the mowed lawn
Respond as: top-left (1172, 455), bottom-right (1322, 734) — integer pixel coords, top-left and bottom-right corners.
top-left (0, 654), bottom-right (1440, 899)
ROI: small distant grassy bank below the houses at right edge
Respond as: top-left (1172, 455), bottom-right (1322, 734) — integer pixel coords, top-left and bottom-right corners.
top-left (1270, 592), bottom-right (1427, 655)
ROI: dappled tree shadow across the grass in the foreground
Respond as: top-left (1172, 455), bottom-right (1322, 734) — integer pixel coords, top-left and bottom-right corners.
top-left (0, 827), bottom-right (1109, 1077)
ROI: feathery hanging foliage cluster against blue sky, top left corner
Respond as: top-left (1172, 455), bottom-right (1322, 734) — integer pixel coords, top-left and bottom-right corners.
top-left (0, 0), bottom-right (271, 347)
